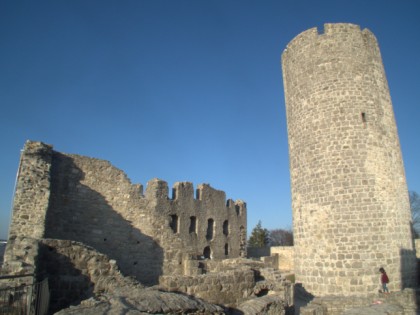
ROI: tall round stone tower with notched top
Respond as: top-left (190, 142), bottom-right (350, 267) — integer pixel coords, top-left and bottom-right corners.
top-left (282, 24), bottom-right (416, 296)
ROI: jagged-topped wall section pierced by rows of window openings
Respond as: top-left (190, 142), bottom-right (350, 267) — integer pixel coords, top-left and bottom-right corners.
top-left (146, 180), bottom-right (246, 274)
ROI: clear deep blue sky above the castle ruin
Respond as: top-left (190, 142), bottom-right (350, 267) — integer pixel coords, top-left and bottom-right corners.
top-left (0, 0), bottom-right (420, 238)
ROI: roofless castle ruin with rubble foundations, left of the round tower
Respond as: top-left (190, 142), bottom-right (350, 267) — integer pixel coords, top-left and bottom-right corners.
top-left (0, 141), bottom-right (293, 314)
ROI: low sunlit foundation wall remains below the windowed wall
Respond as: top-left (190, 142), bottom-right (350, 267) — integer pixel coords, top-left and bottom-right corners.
top-left (160, 258), bottom-right (294, 308)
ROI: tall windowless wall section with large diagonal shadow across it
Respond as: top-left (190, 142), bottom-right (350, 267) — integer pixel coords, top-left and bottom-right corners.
top-left (45, 152), bottom-right (164, 284)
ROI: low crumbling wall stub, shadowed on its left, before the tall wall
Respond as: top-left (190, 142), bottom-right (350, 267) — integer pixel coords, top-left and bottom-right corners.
top-left (38, 239), bottom-right (127, 313)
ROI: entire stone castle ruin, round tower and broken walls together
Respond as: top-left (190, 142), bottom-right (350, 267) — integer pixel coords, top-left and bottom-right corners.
top-left (0, 24), bottom-right (416, 315)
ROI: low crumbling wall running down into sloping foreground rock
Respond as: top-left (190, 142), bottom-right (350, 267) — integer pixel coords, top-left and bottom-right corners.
top-left (38, 239), bottom-right (223, 314)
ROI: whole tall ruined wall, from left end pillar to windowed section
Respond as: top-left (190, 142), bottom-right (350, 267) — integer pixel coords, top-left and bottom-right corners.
top-left (6, 141), bottom-right (246, 285)
